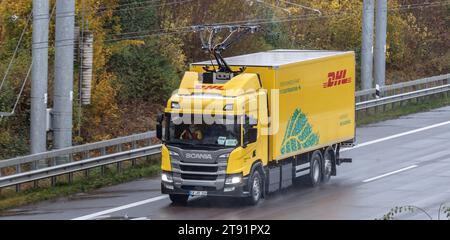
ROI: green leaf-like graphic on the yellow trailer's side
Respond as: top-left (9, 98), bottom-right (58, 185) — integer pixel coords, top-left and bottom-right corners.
top-left (281, 109), bottom-right (320, 154)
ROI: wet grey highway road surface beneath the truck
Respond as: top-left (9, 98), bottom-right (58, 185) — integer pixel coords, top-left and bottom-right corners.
top-left (0, 107), bottom-right (450, 220)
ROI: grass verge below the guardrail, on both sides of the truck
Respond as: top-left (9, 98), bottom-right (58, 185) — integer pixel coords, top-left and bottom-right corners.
top-left (0, 94), bottom-right (450, 211)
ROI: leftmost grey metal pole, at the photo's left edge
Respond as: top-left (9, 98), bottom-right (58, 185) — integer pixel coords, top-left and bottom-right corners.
top-left (30, 0), bottom-right (50, 154)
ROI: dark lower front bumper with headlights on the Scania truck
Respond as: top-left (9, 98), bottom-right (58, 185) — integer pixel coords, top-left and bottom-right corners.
top-left (161, 177), bottom-right (250, 197)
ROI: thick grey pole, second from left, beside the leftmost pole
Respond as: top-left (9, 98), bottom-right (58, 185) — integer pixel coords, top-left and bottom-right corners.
top-left (52, 0), bottom-right (75, 164)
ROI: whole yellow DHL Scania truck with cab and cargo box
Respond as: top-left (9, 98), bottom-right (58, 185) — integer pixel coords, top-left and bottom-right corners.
top-left (157, 50), bottom-right (355, 204)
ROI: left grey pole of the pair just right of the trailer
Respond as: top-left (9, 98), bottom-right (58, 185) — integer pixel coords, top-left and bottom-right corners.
top-left (361, 0), bottom-right (375, 90)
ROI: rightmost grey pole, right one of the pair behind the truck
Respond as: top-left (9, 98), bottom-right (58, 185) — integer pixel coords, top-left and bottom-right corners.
top-left (374, 0), bottom-right (388, 87)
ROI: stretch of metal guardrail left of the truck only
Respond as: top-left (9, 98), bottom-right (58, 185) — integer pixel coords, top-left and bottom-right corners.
top-left (0, 131), bottom-right (159, 191)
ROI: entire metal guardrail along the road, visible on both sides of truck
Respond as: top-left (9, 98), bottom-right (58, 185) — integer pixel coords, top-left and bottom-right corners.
top-left (0, 74), bottom-right (450, 191)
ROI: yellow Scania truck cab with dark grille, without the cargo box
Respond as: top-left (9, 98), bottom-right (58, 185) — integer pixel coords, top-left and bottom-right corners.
top-left (158, 69), bottom-right (268, 203)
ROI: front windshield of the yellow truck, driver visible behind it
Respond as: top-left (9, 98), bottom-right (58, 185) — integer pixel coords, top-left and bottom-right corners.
top-left (166, 114), bottom-right (241, 148)
